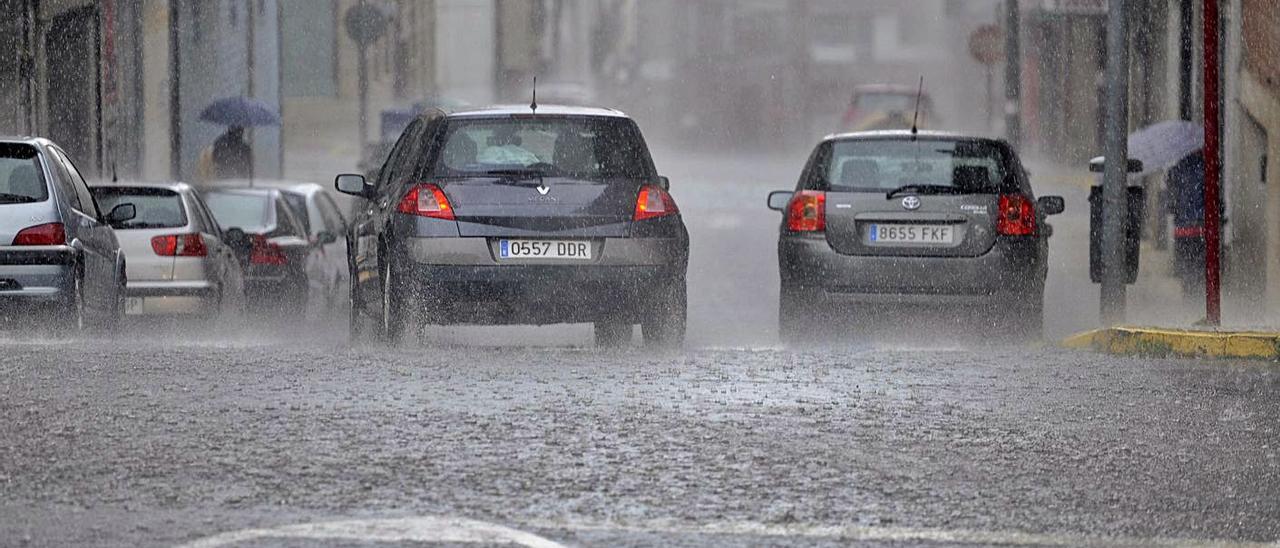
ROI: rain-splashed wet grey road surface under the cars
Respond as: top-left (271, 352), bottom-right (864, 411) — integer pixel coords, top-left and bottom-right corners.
top-left (0, 151), bottom-right (1280, 547)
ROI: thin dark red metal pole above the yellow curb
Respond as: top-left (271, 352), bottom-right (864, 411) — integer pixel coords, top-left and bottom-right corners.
top-left (1204, 0), bottom-right (1222, 326)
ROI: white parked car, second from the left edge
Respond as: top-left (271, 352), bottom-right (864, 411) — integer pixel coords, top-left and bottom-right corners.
top-left (92, 183), bottom-right (244, 319)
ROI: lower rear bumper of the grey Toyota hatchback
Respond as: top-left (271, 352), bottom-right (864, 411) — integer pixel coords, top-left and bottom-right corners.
top-left (778, 234), bottom-right (1047, 299)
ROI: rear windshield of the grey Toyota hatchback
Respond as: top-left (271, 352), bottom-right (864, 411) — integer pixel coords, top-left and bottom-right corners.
top-left (823, 138), bottom-right (1007, 193)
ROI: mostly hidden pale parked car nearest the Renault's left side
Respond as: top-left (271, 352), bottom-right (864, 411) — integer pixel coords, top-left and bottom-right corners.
top-left (207, 181), bottom-right (349, 311)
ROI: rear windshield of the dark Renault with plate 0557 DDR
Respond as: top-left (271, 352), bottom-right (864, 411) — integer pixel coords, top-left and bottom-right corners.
top-left (433, 117), bottom-right (652, 179)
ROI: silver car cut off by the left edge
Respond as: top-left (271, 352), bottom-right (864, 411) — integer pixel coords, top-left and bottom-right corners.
top-left (0, 138), bottom-right (134, 332)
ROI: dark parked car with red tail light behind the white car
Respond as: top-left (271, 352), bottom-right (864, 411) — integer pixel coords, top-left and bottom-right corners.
top-left (204, 188), bottom-right (317, 314)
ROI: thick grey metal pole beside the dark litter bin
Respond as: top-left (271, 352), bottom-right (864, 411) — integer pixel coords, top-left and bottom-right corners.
top-left (1102, 0), bottom-right (1129, 325)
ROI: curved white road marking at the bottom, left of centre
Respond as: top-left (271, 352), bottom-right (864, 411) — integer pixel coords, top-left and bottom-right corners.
top-left (179, 516), bottom-right (564, 548)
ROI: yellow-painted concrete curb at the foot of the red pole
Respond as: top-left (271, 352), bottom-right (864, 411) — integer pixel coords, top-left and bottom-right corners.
top-left (1062, 328), bottom-right (1280, 361)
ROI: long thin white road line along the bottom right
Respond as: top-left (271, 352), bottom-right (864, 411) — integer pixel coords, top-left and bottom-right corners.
top-left (521, 521), bottom-right (1280, 548)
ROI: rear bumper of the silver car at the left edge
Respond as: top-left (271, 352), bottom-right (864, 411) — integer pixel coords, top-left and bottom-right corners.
top-left (0, 246), bottom-right (77, 302)
